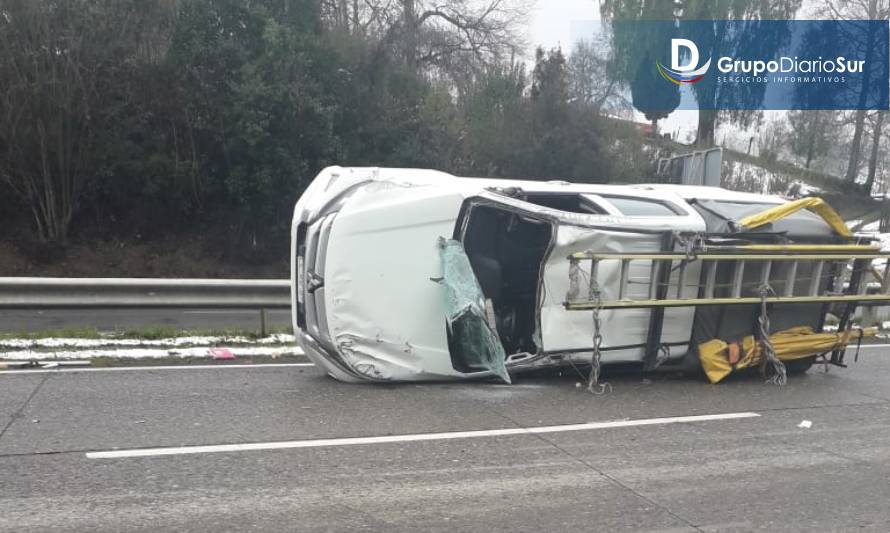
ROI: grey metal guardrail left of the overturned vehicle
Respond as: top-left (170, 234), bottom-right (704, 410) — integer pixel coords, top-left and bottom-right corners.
top-left (0, 277), bottom-right (291, 309)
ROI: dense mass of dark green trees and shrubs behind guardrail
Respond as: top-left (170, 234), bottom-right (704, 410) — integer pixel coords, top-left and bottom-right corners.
top-left (0, 0), bottom-right (640, 260)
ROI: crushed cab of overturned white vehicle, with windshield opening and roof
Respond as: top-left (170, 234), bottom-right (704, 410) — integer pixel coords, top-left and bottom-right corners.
top-left (452, 189), bottom-right (704, 368)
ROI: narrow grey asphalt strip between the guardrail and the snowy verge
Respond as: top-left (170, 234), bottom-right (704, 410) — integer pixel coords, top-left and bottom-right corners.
top-left (0, 309), bottom-right (291, 333)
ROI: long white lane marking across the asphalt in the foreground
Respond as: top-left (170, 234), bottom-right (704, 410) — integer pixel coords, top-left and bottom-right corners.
top-left (86, 412), bottom-right (760, 459)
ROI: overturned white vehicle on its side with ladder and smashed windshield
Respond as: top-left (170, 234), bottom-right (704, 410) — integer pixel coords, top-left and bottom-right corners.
top-left (291, 167), bottom-right (890, 382)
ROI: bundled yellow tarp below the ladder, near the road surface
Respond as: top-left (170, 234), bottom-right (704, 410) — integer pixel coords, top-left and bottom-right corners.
top-left (698, 326), bottom-right (878, 383)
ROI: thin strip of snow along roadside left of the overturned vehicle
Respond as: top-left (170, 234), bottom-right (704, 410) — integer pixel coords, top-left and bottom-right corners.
top-left (0, 334), bottom-right (296, 349)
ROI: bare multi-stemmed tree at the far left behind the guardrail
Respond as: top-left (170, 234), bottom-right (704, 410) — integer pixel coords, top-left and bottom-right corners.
top-left (0, 0), bottom-right (171, 242)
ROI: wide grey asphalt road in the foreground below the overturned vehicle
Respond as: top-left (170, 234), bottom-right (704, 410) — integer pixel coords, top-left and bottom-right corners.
top-left (0, 349), bottom-right (890, 532)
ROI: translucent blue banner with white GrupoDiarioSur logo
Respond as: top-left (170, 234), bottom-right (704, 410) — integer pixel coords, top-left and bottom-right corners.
top-left (601, 20), bottom-right (890, 110)
